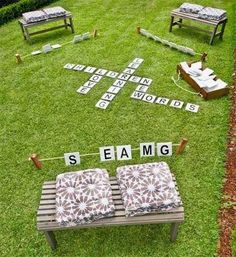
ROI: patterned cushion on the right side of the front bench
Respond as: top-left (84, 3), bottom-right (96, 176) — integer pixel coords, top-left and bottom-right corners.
top-left (117, 162), bottom-right (181, 216)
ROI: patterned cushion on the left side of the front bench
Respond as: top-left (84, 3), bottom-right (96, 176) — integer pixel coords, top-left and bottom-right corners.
top-left (56, 169), bottom-right (115, 227)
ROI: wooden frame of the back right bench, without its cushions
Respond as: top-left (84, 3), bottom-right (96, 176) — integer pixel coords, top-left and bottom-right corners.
top-left (169, 9), bottom-right (228, 45)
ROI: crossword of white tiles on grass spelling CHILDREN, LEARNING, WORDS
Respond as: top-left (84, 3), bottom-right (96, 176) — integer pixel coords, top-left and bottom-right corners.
top-left (64, 58), bottom-right (199, 113)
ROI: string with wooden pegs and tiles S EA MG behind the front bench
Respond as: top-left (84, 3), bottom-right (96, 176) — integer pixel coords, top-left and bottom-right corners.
top-left (29, 138), bottom-right (188, 169)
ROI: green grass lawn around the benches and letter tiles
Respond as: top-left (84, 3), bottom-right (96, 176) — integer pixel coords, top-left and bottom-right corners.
top-left (0, 0), bottom-right (235, 257)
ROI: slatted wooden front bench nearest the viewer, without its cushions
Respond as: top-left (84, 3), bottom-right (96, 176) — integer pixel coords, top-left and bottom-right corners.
top-left (37, 177), bottom-right (184, 250)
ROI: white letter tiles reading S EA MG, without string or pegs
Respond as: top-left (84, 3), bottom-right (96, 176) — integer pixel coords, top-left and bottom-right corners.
top-left (64, 142), bottom-right (173, 166)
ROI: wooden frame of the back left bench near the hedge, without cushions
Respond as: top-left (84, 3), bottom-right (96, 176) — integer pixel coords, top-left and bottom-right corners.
top-left (18, 12), bottom-right (74, 42)
